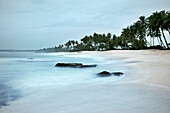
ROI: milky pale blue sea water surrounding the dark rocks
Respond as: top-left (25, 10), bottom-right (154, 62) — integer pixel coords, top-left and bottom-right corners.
top-left (0, 52), bottom-right (126, 107)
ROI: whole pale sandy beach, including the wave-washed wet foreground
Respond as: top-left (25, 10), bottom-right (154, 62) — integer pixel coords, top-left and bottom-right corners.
top-left (0, 50), bottom-right (170, 113)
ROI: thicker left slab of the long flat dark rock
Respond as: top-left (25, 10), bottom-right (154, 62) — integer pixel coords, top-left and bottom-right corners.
top-left (55, 63), bottom-right (83, 68)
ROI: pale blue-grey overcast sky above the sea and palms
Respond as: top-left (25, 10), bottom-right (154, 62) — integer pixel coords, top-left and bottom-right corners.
top-left (0, 0), bottom-right (170, 49)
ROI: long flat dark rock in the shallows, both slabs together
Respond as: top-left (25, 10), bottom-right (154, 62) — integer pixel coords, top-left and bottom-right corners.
top-left (55, 63), bottom-right (97, 68)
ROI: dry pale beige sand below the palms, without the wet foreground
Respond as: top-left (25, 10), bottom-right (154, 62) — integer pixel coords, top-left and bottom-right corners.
top-left (95, 50), bottom-right (170, 87)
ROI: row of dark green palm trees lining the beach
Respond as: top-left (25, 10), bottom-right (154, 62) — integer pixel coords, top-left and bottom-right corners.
top-left (39, 10), bottom-right (170, 51)
